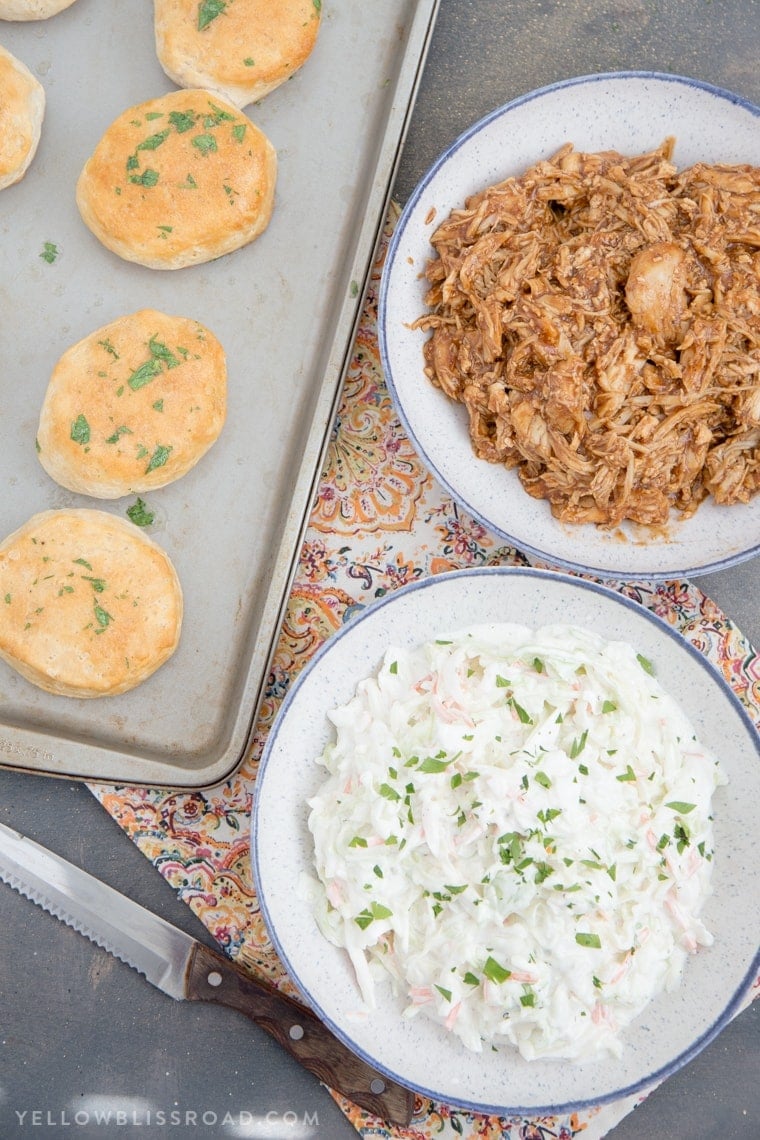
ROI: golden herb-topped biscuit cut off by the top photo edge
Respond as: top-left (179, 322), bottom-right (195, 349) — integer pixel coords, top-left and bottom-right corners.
top-left (154, 0), bottom-right (321, 107)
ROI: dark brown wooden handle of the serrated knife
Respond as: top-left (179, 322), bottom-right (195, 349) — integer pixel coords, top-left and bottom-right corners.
top-left (186, 943), bottom-right (415, 1124)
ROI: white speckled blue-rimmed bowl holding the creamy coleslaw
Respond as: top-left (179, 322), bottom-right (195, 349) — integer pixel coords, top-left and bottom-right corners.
top-left (251, 568), bottom-right (760, 1114)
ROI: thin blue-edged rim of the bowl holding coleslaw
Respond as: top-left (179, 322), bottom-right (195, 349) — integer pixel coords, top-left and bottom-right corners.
top-left (251, 565), bottom-right (760, 1116)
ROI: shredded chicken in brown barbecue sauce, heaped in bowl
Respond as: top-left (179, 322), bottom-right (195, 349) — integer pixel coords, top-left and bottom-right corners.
top-left (416, 139), bottom-right (760, 528)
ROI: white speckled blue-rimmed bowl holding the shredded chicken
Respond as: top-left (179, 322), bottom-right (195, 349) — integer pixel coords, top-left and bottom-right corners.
top-left (378, 72), bottom-right (760, 580)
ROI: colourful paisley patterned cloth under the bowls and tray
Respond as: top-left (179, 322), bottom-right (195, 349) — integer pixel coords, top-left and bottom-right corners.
top-left (91, 207), bottom-right (760, 1140)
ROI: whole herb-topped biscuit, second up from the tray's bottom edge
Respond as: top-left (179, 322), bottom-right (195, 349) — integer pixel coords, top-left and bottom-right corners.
top-left (36, 309), bottom-right (227, 498)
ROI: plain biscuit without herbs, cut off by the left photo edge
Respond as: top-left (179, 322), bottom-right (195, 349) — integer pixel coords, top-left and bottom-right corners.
top-left (0, 47), bottom-right (44, 190)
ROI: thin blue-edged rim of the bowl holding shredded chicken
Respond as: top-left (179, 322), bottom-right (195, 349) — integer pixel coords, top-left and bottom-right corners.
top-left (377, 70), bottom-right (760, 581)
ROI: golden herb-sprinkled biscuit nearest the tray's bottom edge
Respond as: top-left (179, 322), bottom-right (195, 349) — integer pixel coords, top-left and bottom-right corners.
top-left (0, 510), bottom-right (182, 698)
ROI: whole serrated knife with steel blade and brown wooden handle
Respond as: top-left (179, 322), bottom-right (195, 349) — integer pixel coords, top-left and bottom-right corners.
top-left (0, 823), bottom-right (414, 1124)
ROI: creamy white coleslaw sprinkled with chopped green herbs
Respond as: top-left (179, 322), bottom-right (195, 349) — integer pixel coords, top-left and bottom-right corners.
top-left (309, 624), bottom-right (726, 1060)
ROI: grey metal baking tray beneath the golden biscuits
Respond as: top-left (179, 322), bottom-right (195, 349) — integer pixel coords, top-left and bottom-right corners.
top-left (0, 0), bottom-right (439, 788)
